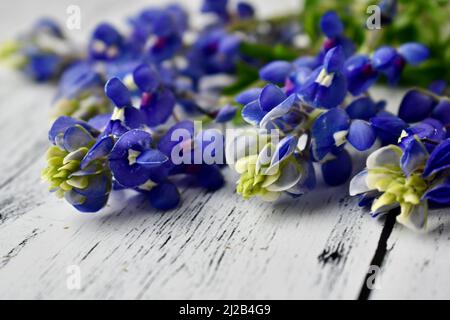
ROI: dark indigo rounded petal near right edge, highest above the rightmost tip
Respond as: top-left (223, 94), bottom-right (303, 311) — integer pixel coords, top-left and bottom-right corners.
top-left (398, 89), bottom-right (437, 122)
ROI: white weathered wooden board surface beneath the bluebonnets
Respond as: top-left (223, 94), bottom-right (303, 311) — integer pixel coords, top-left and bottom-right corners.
top-left (0, 0), bottom-right (450, 299)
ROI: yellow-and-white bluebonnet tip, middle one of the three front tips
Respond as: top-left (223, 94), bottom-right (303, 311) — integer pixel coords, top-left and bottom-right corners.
top-left (226, 131), bottom-right (316, 201)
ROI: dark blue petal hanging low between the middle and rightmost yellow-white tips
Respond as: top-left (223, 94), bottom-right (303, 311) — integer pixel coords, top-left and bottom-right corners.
top-left (322, 150), bottom-right (352, 186)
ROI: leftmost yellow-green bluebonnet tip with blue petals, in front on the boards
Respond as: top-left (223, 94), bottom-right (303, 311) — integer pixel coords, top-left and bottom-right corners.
top-left (42, 117), bottom-right (111, 212)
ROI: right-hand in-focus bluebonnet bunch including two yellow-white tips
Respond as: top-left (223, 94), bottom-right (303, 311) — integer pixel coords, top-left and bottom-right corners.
top-left (227, 8), bottom-right (450, 229)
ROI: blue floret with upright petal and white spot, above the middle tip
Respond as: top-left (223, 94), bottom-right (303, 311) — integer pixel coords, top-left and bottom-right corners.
top-left (299, 46), bottom-right (347, 109)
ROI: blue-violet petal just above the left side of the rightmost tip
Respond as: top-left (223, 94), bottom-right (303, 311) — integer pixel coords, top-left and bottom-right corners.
top-left (370, 114), bottom-right (408, 145)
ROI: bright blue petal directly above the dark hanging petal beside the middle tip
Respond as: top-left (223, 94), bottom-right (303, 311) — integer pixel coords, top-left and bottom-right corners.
top-left (311, 108), bottom-right (350, 160)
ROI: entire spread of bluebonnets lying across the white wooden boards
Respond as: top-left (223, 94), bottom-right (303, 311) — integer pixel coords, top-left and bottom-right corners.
top-left (0, 0), bottom-right (450, 230)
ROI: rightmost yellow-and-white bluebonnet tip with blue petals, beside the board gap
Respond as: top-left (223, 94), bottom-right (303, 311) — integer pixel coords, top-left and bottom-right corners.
top-left (350, 139), bottom-right (450, 230)
